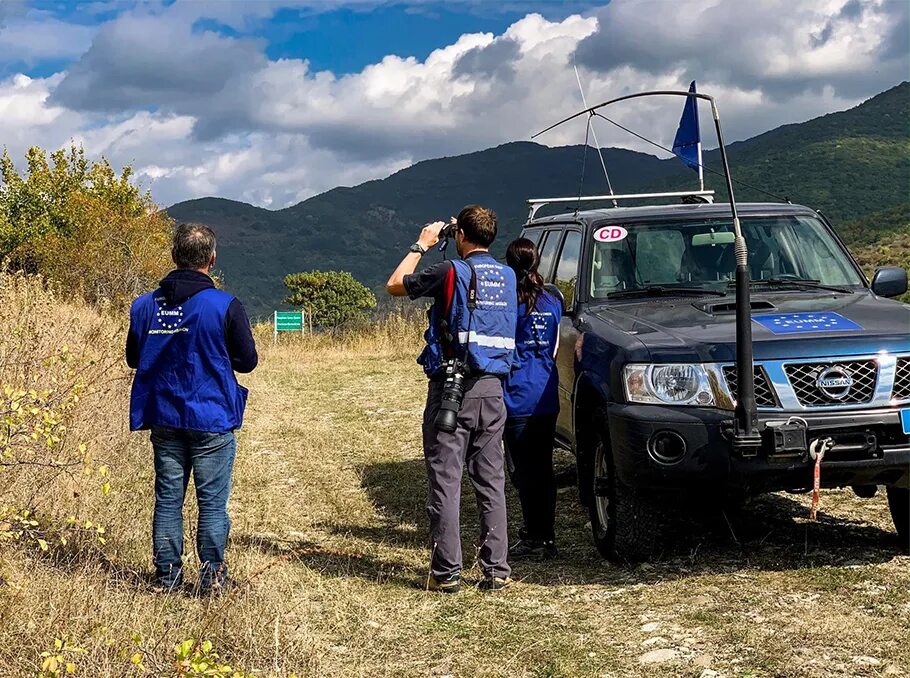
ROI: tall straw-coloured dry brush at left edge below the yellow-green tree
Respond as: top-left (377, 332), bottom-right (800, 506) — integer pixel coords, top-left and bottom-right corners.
top-left (0, 271), bottom-right (125, 580)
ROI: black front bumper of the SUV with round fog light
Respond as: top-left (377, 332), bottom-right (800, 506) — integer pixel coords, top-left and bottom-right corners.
top-left (608, 404), bottom-right (910, 492)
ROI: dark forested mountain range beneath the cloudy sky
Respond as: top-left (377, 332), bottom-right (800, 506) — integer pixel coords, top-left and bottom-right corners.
top-left (168, 82), bottom-right (910, 316)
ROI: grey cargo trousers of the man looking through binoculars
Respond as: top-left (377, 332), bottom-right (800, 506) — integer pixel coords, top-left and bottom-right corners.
top-left (423, 378), bottom-right (511, 579)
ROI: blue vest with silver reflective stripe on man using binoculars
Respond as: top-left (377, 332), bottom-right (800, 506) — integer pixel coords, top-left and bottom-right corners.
top-left (417, 253), bottom-right (518, 377)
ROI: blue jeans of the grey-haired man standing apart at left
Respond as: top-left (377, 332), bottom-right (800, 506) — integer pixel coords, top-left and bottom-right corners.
top-left (151, 426), bottom-right (237, 589)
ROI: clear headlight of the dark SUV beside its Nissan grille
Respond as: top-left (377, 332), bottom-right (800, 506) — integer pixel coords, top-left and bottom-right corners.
top-left (624, 364), bottom-right (715, 406)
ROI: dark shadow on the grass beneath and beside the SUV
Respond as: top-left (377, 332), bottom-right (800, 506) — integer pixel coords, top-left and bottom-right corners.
top-left (348, 459), bottom-right (900, 585)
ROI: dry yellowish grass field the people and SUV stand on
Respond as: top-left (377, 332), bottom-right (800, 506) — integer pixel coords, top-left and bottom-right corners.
top-left (0, 284), bottom-right (910, 677)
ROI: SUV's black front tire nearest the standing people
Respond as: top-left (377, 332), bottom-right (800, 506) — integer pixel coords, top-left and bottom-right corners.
top-left (588, 413), bottom-right (664, 564)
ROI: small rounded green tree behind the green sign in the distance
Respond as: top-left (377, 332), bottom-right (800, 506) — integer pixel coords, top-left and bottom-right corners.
top-left (284, 271), bottom-right (376, 328)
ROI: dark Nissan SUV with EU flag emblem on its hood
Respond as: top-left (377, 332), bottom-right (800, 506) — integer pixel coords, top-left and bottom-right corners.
top-left (522, 204), bottom-right (910, 561)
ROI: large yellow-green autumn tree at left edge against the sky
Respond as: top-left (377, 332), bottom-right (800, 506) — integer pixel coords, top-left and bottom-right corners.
top-left (0, 145), bottom-right (172, 306)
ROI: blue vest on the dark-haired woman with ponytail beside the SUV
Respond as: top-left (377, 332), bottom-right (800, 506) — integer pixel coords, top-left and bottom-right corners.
top-left (502, 291), bottom-right (562, 417)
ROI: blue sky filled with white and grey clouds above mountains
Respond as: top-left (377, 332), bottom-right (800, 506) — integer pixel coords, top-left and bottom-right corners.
top-left (0, 0), bottom-right (910, 208)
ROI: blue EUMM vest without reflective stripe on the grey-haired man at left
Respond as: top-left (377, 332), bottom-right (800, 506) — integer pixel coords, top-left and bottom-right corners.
top-left (130, 289), bottom-right (247, 433)
